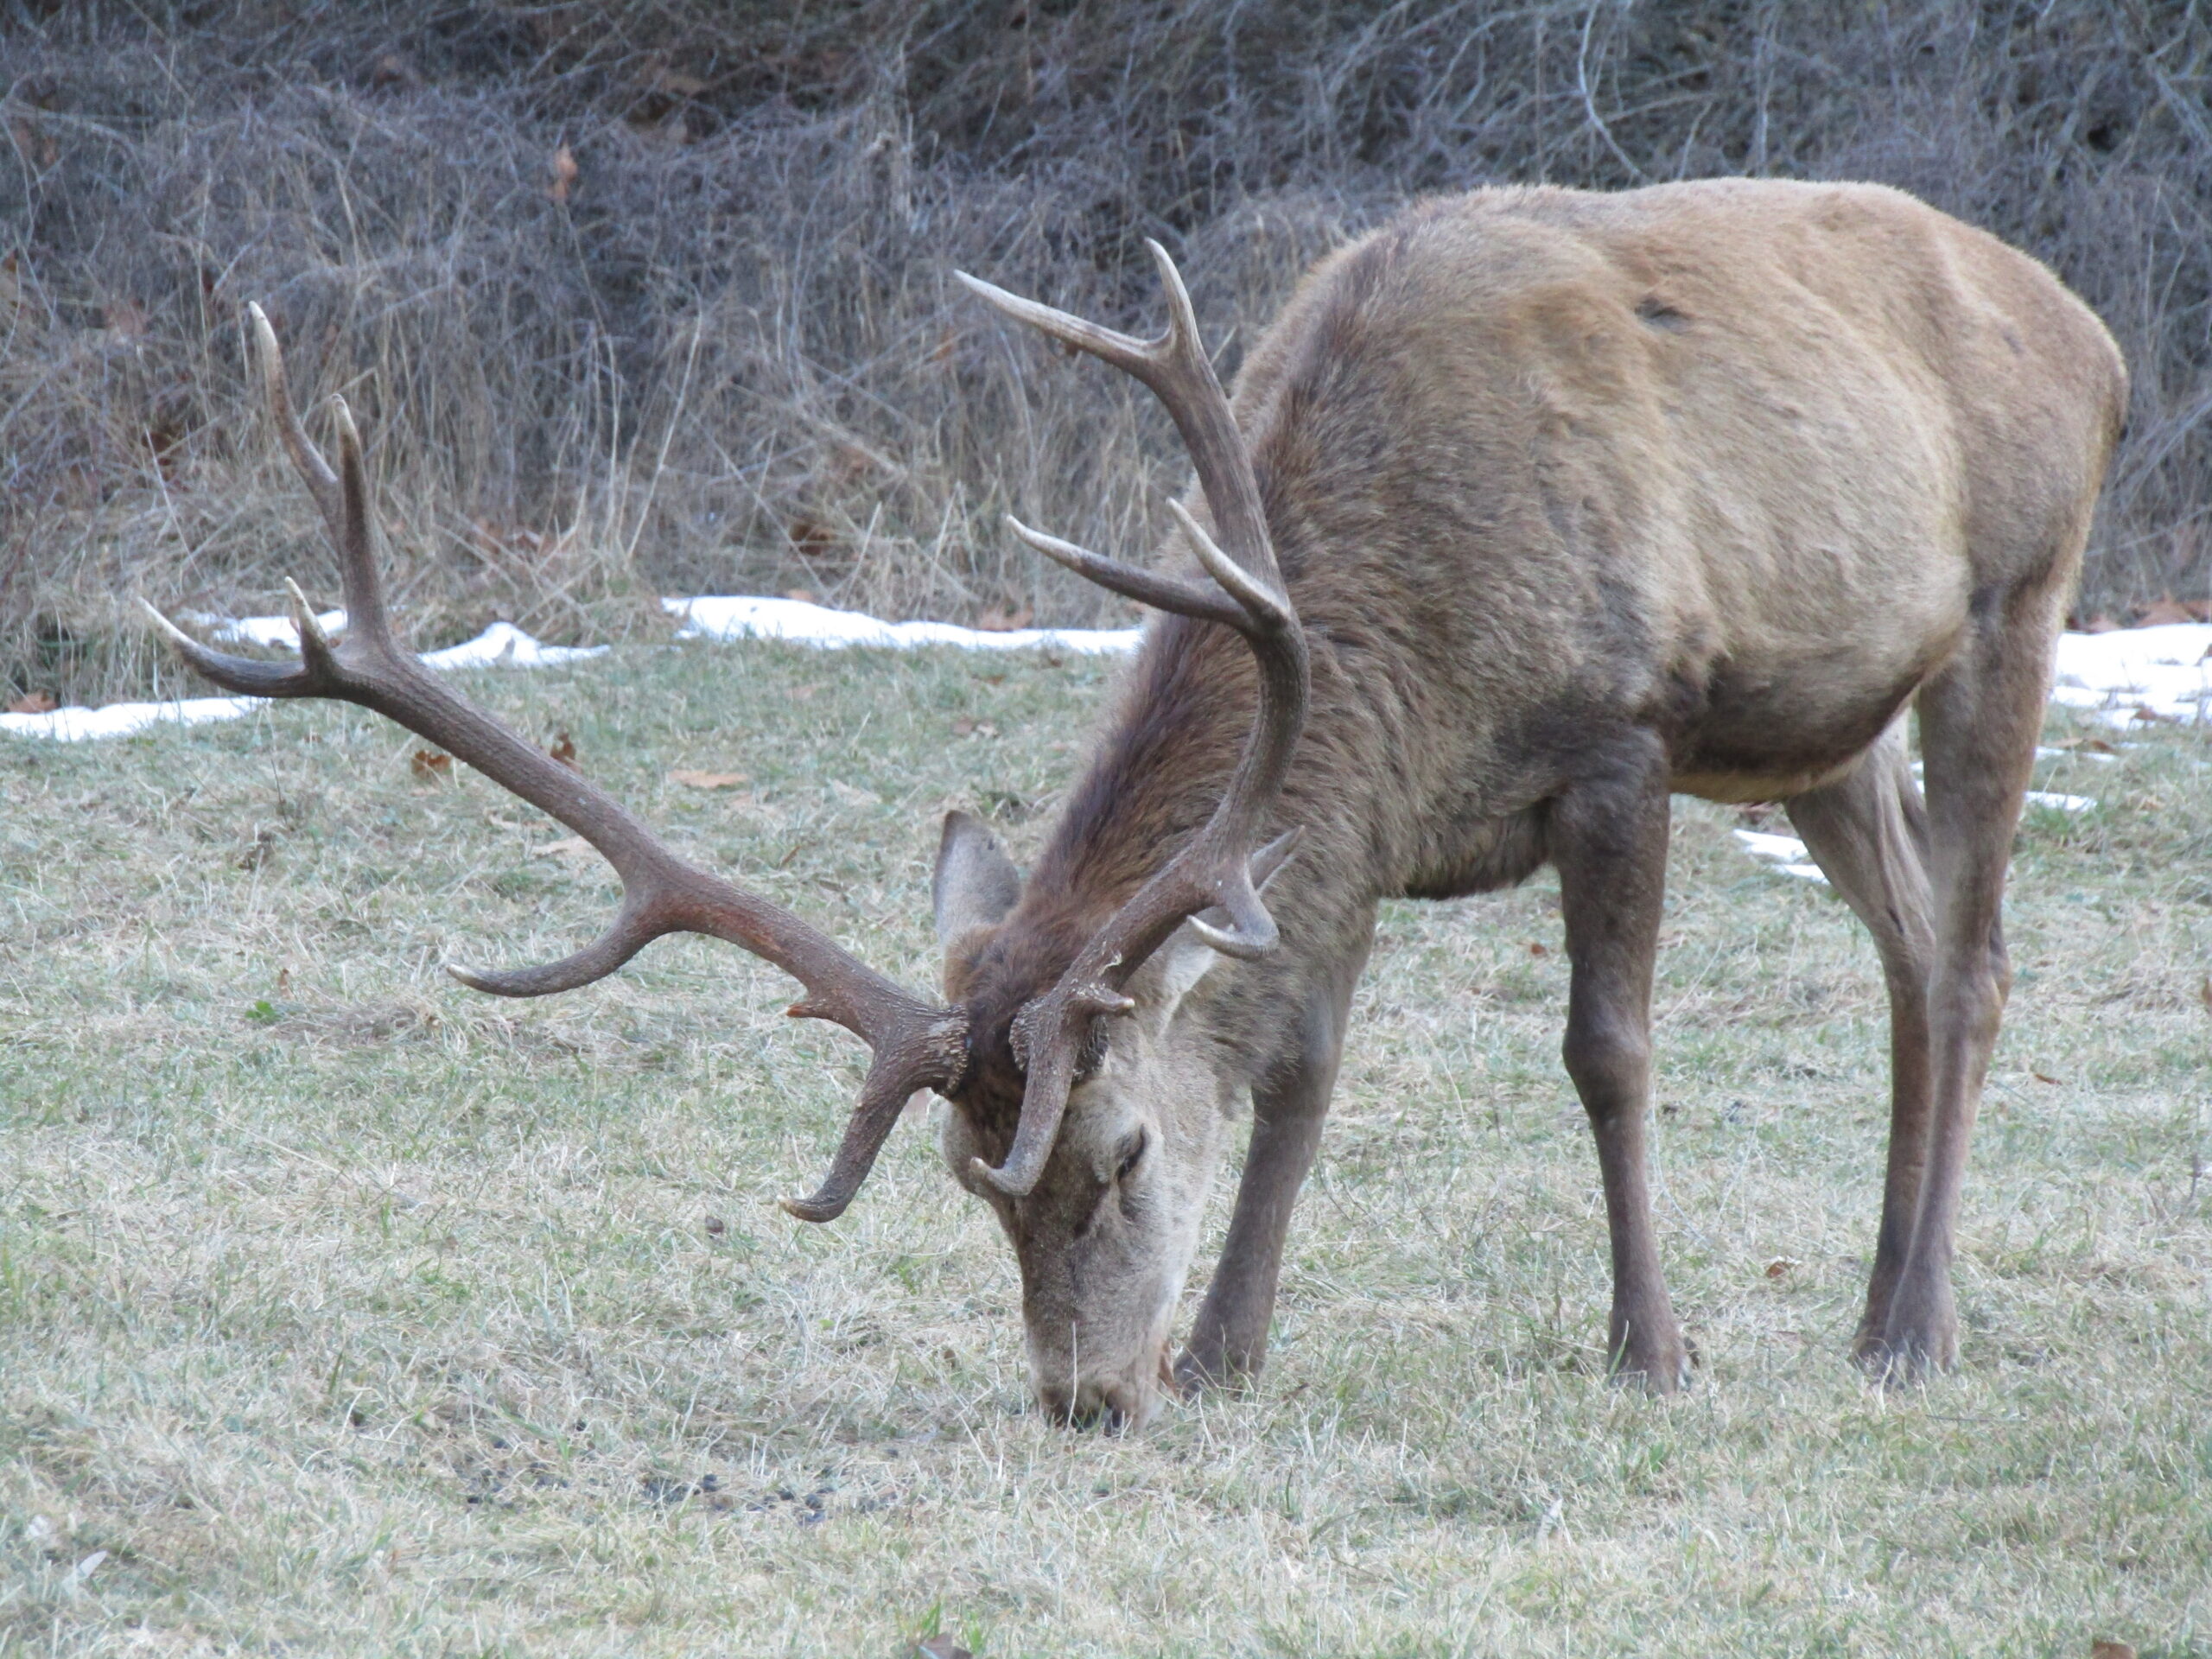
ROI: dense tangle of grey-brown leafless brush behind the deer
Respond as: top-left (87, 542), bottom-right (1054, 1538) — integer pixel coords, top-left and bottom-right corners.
top-left (0, 0), bottom-right (2212, 702)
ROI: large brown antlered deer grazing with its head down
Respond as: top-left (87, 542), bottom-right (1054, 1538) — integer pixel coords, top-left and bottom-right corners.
top-left (163, 181), bottom-right (2126, 1422)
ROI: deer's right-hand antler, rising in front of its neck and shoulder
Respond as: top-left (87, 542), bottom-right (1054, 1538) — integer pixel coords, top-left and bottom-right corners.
top-left (960, 241), bottom-right (1307, 1197)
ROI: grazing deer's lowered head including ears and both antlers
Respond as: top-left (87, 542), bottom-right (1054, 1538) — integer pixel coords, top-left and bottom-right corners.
top-left (149, 244), bottom-right (1307, 1422)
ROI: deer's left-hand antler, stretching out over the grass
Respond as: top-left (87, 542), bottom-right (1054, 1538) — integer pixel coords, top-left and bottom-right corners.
top-left (146, 305), bottom-right (969, 1221)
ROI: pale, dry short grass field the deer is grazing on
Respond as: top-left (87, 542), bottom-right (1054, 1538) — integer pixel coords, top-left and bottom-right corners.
top-left (0, 646), bottom-right (2212, 1659)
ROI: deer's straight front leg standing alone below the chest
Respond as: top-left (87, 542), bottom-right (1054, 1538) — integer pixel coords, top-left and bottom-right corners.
top-left (1546, 732), bottom-right (1690, 1394)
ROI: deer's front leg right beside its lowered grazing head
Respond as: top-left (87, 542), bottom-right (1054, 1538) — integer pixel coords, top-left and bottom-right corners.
top-left (1174, 916), bottom-right (1374, 1391)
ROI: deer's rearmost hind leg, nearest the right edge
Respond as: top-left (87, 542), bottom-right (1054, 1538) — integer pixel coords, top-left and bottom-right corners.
top-left (1873, 588), bottom-right (2057, 1376)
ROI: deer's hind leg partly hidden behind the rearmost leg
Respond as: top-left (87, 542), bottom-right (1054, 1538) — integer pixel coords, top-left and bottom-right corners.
top-left (1789, 721), bottom-right (1936, 1360)
